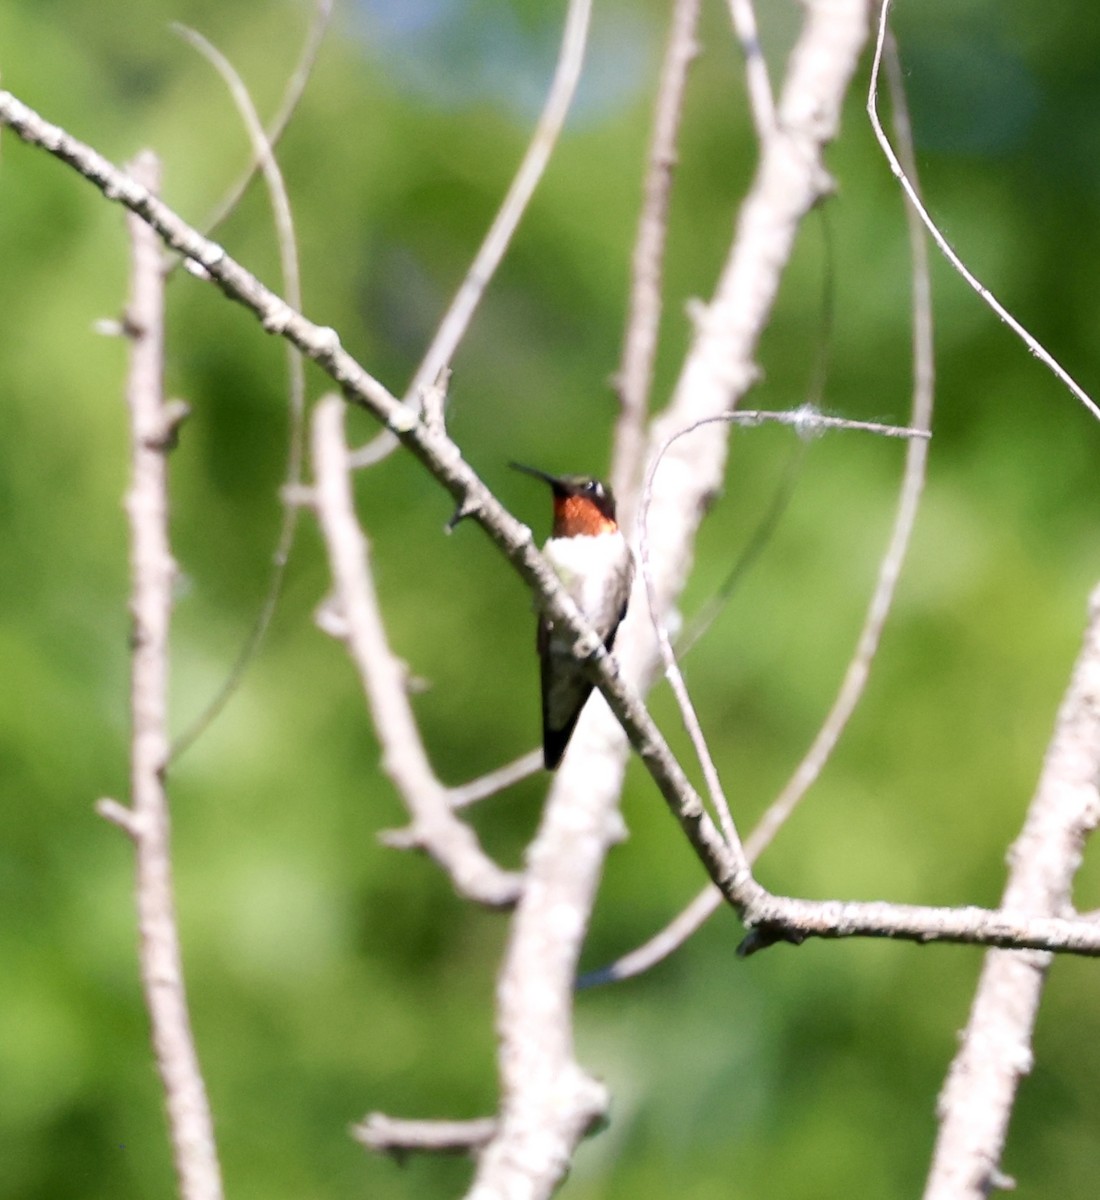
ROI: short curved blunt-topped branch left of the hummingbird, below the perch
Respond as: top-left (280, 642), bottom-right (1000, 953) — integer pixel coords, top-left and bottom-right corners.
top-left (313, 396), bottom-right (522, 908)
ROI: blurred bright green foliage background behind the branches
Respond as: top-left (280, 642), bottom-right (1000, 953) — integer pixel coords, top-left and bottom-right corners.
top-left (0, 0), bottom-right (1100, 1200)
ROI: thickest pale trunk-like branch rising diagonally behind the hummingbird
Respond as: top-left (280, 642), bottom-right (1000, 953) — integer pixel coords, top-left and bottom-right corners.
top-left (470, 7), bottom-right (866, 1200)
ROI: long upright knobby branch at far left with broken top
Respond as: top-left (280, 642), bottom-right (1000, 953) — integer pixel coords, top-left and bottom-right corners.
top-left (101, 154), bottom-right (222, 1200)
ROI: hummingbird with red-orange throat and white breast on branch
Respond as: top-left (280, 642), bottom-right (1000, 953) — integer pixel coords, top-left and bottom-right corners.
top-left (510, 462), bottom-right (635, 770)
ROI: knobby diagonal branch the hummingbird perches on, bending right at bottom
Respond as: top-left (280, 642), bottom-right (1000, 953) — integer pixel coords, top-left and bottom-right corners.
top-left (0, 63), bottom-right (1100, 955)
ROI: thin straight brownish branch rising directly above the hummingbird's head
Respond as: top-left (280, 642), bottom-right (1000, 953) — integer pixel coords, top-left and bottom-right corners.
top-left (611, 0), bottom-right (699, 498)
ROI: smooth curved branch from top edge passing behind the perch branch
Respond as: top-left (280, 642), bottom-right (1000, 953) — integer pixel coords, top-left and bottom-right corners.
top-left (353, 0), bottom-right (591, 467)
